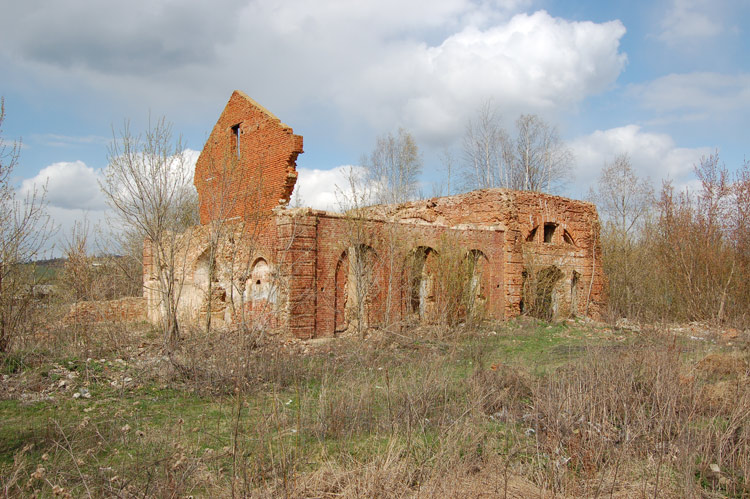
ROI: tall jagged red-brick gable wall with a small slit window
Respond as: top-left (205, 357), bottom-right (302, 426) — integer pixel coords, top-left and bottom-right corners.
top-left (194, 90), bottom-right (303, 224)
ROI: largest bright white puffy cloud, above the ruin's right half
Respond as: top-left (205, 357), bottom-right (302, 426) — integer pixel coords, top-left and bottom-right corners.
top-left (331, 11), bottom-right (627, 143)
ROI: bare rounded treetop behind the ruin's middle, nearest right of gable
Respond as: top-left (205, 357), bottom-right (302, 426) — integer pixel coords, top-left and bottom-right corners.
top-left (363, 128), bottom-right (422, 204)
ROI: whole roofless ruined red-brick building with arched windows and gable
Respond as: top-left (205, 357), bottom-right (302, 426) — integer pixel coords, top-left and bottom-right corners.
top-left (144, 91), bottom-right (605, 338)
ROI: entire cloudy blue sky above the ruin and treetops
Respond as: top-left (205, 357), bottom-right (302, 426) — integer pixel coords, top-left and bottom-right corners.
top-left (0, 0), bottom-right (750, 252)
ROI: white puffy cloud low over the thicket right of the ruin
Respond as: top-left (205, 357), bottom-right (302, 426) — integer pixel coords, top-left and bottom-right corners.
top-left (571, 125), bottom-right (713, 195)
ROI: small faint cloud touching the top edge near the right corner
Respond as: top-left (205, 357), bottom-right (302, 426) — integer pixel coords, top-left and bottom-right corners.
top-left (659, 0), bottom-right (725, 46)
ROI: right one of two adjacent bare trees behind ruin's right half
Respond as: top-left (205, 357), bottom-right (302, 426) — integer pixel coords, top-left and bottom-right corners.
top-left (503, 114), bottom-right (573, 192)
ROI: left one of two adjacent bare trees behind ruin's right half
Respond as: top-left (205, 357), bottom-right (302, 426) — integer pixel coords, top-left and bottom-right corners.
top-left (463, 100), bottom-right (510, 189)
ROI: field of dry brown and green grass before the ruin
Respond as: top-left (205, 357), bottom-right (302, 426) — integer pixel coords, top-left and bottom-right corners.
top-left (0, 320), bottom-right (750, 497)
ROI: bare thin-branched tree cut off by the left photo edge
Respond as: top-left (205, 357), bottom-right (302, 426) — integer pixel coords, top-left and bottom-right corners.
top-left (0, 98), bottom-right (53, 352)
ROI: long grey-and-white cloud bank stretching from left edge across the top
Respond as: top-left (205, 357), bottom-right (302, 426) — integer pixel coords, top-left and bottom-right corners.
top-left (0, 0), bottom-right (626, 143)
